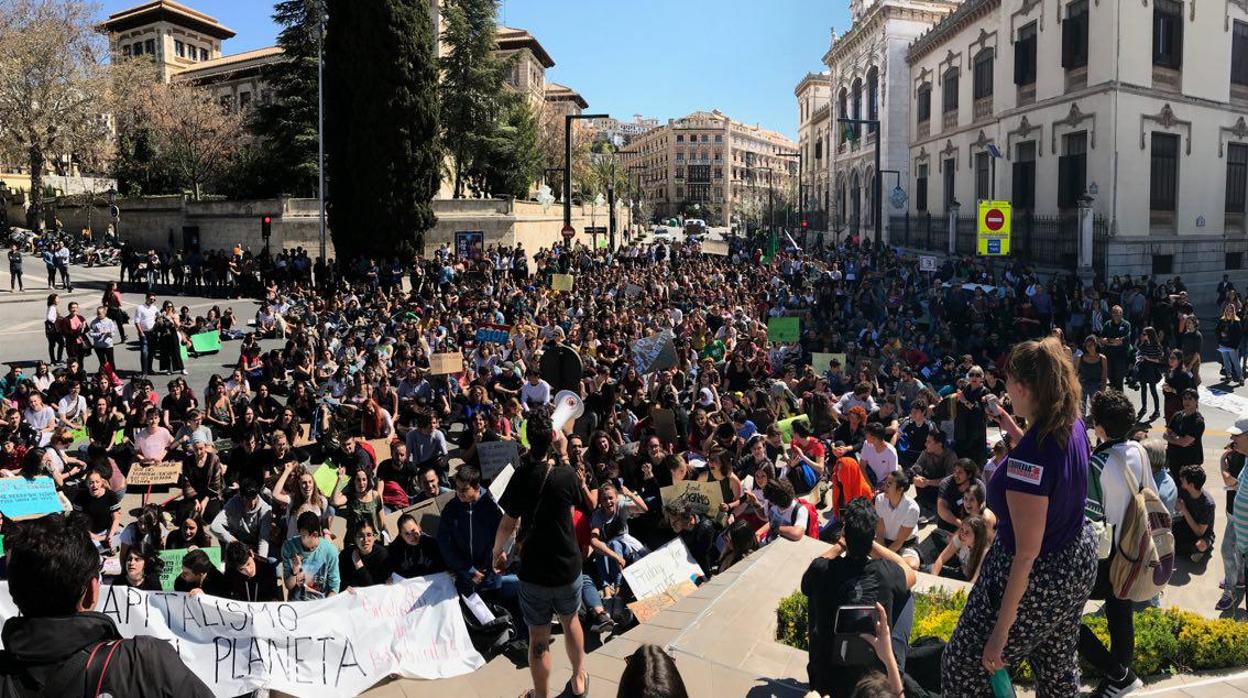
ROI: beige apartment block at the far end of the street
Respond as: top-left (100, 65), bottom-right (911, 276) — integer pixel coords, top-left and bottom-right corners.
top-left (620, 110), bottom-right (797, 226)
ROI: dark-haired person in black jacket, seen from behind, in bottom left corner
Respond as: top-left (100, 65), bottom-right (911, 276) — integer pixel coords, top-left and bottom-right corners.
top-left (0, 516), bottom-right (213, 698)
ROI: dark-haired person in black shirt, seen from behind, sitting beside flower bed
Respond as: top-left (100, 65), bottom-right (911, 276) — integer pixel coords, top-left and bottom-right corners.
top-left (801, 499), bottom-right (916, 698)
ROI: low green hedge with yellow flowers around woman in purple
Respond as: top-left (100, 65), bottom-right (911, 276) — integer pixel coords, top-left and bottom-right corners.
top-left (776, 589), bottom-right (1248, 684)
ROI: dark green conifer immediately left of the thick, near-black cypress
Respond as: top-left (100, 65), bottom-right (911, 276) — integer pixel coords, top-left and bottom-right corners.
top-left (248, 0), bottom-right (321, 196)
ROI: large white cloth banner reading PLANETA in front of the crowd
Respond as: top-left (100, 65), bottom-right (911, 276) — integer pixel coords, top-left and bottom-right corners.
top-left (0, 574), bottom-right (485, 698)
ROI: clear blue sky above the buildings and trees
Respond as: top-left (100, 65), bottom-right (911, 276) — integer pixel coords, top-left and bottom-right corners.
top-left (101, 0), bottom-right (849, 137)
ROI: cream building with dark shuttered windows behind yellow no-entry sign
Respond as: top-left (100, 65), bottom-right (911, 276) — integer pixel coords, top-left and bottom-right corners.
top-left (905, 0), bottom-right (1248, 280)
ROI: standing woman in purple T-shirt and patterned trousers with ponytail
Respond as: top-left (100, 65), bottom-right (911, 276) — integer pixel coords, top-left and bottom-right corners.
top-left (942, 337), bottom-right (1097, 698)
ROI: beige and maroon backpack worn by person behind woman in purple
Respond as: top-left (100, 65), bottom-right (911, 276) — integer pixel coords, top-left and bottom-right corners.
top-left (1109, 457), bottom-right (1174, 602)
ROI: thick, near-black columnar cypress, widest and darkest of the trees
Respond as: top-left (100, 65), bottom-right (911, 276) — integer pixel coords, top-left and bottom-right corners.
top-left (324, 0), bottom-right (442, 258)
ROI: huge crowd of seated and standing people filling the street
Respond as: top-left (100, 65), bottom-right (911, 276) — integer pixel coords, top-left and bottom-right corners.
top-left (0, 231), bottom-right (1248, 697)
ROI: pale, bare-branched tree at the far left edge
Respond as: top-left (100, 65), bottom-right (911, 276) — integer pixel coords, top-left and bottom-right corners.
top-left (0, 0), bottom-right (111, 229)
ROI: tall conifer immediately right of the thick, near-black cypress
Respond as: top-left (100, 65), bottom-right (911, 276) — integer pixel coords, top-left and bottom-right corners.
top-left (441, 0), bottom-right (514, 199)
